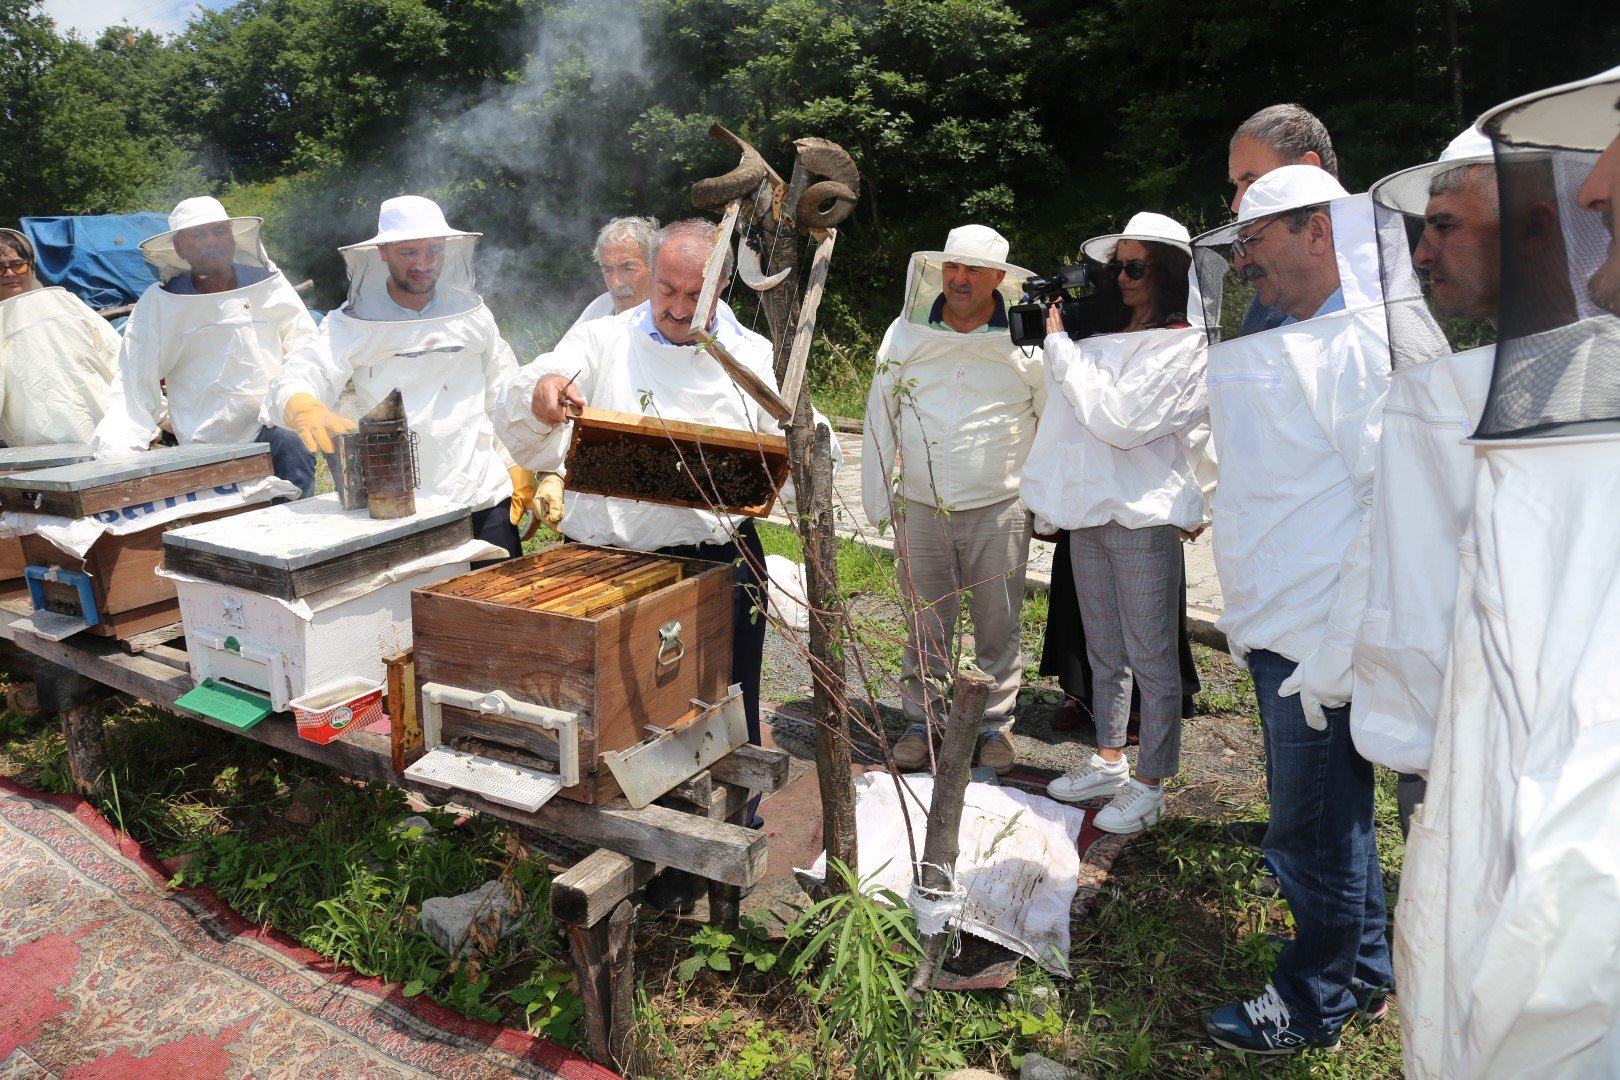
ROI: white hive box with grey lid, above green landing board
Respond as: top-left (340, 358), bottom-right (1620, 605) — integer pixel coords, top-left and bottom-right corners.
top-left (164, 494), bottom-right (473, 709)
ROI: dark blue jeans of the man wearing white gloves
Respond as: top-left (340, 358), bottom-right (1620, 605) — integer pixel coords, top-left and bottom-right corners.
top-left (1249, 649), bottom-right (1395, 1031)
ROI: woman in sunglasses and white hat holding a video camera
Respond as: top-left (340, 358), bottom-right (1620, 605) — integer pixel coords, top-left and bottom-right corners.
top-left (1019, 214), bottom-right (1209, 832)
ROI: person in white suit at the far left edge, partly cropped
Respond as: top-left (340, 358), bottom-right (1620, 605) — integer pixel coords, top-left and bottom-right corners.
top-left (0, 228), bottom-right (118, 447)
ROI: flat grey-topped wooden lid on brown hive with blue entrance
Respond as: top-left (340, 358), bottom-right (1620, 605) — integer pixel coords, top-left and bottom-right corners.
top-left (0, 442), bottom-right (271, 518)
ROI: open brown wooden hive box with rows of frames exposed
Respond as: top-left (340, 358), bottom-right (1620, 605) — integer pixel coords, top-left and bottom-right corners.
top-left (411, 544), bottom-right (734, 803)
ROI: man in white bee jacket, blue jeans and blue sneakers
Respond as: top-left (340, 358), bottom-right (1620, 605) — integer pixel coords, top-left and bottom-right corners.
top-left (1194, 165), bottom-right (1392, 1054)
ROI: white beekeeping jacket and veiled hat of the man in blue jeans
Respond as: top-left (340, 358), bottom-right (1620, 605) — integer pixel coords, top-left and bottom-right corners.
top-left (1192, 165), bottom-right (1390, 693)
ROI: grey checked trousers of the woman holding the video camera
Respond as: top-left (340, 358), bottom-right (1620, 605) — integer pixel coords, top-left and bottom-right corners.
top-left (1069, 521), bottom-right (1181, 779)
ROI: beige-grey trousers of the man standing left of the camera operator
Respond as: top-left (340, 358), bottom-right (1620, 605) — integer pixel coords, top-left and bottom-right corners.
top-left (894, 497), bottom-right (1030, 732)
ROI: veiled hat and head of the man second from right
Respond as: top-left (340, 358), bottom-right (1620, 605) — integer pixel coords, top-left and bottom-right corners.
top-left (1371, 128), bottom-right (1502, 369)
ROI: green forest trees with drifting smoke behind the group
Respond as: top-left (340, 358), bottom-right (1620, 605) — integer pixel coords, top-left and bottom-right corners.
top-left (0, 0), bottom-right (1620, 404)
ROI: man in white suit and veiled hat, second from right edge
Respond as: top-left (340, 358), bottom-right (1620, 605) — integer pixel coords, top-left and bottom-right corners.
top-left (1349, 128), bottom-right (1502, 829)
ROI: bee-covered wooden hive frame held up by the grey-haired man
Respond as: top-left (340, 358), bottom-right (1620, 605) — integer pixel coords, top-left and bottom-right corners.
top-left (567, 408), bottom-right (792, 518)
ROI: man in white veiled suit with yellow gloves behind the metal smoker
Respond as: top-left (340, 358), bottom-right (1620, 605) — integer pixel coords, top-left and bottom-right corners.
top-left (266, 194), bottom-right (535, 557)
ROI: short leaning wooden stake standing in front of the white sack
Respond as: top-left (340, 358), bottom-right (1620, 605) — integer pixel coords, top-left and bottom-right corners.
top-left (910, 667), bottom-right (995, 1002)
